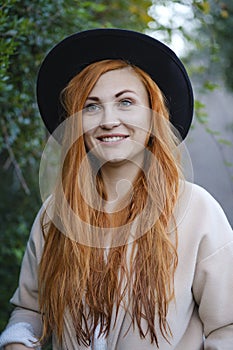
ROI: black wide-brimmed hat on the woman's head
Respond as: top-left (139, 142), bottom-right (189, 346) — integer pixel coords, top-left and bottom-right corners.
top-left (37, 29), bottom-right (193, 139)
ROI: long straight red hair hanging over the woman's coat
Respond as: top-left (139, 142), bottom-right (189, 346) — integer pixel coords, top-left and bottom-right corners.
top-left (39, 60), bottom-right (180, 346)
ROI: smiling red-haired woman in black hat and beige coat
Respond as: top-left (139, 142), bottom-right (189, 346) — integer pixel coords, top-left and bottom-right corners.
top-left (0, 29), bottom-right (233, 350)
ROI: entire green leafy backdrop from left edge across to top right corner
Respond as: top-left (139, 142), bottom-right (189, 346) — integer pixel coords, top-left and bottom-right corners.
top-left (0, 0), bottom-right (233, 346)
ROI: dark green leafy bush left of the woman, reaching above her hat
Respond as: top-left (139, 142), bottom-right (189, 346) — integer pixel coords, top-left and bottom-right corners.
top-left (0, 0), bottom-right (151, 342)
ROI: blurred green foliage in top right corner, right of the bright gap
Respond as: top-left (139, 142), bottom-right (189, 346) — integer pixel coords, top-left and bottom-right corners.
top-left (193, 0), bottom-right (233, 91)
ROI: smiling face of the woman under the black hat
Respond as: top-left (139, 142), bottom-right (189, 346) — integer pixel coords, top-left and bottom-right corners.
top-left (82, 67), bottom-right (151, 164)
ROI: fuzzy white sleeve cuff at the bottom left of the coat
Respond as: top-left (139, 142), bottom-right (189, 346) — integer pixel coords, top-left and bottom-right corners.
top-left (0, 322), bottom-right (41, 350)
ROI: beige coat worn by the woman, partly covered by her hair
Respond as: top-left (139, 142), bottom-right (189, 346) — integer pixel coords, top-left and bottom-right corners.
top-left (4, 183), bottom-right (233, 350)
